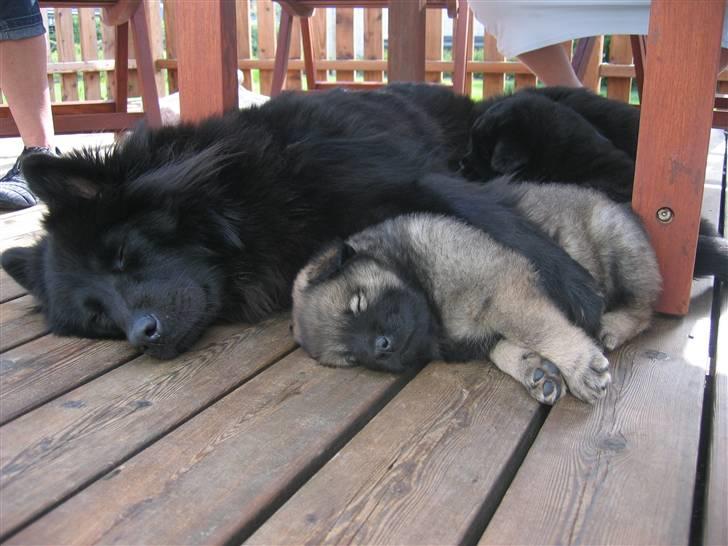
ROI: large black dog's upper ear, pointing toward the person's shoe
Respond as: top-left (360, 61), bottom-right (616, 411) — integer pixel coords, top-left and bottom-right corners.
top-left (21, 154), bottom-right (101, 209)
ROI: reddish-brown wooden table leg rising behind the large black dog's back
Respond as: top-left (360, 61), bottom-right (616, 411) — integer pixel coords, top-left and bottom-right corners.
top-left (387, 0), bottom-right (426, 82)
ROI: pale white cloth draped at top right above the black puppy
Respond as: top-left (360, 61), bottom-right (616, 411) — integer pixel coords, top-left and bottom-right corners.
top-left (469, 0), bottom-right (728, 57)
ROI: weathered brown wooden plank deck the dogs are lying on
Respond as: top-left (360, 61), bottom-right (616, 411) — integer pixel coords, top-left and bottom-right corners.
top-left (0, 134), bottom-right (728, 545)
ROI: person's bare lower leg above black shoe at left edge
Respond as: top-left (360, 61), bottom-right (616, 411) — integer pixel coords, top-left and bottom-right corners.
top-left (0, 34), bottom-right (54, 148)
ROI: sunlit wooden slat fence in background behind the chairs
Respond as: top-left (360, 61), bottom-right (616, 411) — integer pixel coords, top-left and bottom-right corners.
top-left (5, 0), bottom-right (712, 106)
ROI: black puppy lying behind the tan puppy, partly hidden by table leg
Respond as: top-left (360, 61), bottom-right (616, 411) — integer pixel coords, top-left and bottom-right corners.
top-left (461, 87), bottom-right (728, 281)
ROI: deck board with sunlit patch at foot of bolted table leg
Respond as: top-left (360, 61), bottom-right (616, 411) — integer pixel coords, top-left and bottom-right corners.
top-left (480, 281), bottom-right (712, 545)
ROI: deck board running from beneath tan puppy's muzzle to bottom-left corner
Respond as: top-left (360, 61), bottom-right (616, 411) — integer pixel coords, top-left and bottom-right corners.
top-left (8, 350), bottom-right (406, 544)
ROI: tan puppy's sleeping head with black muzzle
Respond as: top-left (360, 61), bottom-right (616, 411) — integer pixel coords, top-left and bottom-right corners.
top-left (293, 242), bottom-right (438, 372)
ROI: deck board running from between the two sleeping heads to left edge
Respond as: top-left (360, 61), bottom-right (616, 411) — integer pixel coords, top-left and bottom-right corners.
top-left (0, 318), bottom-right (294, 535)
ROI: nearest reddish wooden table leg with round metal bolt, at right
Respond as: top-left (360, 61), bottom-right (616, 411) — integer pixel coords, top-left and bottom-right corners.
top-left (632, 0), bottom-right (725, 315)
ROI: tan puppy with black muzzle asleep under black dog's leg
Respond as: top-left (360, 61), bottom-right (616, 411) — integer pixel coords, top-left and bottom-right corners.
top-left (293, 180), bottom-right (661, 404)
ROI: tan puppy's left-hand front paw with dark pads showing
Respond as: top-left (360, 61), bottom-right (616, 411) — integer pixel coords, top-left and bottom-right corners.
top-left (489, 339), bottom-right (566, 406)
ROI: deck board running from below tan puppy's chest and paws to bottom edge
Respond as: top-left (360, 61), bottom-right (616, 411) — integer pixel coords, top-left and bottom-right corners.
top-left (246, 362), bottom-right (543, 544)
